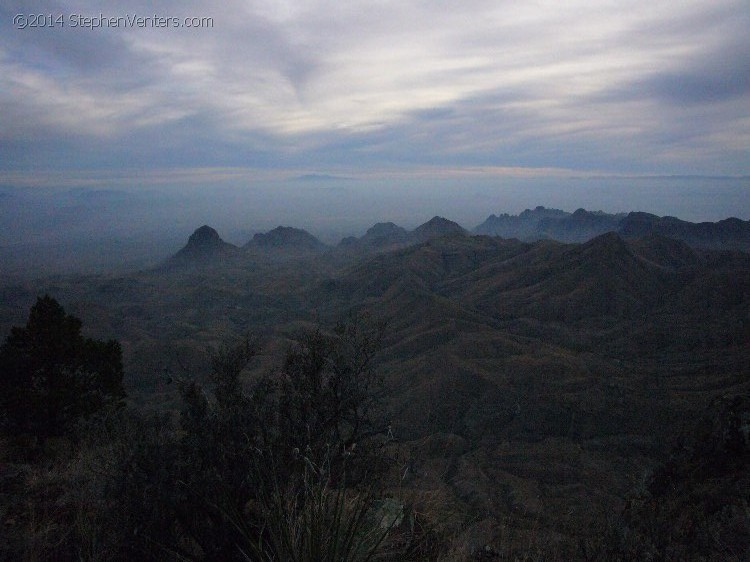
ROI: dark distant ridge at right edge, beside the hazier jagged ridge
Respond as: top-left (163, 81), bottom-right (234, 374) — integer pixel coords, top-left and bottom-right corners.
top-left (620, 213), bottom-right (750, 251)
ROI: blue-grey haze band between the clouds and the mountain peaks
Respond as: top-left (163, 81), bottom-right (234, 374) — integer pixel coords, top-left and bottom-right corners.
top-left (0, 170), bottom-right (750, 278)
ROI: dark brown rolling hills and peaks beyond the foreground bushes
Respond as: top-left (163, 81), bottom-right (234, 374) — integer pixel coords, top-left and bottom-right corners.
top-left (0, 214), bottom-right (750, 560)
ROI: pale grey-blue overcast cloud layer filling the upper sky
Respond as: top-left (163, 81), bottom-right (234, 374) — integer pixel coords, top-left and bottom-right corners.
top-left (0, 0), bottom-right (750, 177)
